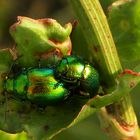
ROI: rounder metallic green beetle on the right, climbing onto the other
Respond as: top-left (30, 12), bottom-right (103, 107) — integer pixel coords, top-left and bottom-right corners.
top-left (55, 55), bottom-right (100, 97)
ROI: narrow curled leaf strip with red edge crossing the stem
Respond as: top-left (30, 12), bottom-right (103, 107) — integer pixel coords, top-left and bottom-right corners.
top-left (89, 65), bottom-right (140, 108)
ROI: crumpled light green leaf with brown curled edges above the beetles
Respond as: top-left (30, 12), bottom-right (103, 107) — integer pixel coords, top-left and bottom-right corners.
top-left (10, 17), bottom-right (72, 67)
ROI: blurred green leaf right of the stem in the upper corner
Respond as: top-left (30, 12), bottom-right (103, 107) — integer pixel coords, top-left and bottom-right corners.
top-left (108, 0), bottom-right (140, 69)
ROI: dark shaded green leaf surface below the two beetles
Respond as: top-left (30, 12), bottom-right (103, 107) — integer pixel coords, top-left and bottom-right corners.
top-left (0, 94), bottom-right (87, 140)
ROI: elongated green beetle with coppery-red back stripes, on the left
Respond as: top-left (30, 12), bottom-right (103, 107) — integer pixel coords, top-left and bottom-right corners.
top-left (4, 68), bottom-right (69, 106)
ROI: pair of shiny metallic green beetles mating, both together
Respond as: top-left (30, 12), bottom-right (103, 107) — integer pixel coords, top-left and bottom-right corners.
top-left (4, 55), bottom-right (99, 106)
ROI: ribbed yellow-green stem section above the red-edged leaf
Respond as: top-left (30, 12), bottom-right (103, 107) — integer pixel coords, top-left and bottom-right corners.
top-left (71, 0), bottom-right (122, 86)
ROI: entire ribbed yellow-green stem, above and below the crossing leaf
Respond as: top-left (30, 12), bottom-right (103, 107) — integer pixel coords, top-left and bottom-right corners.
top-left (70, 0), bottom-right (140, 140)
